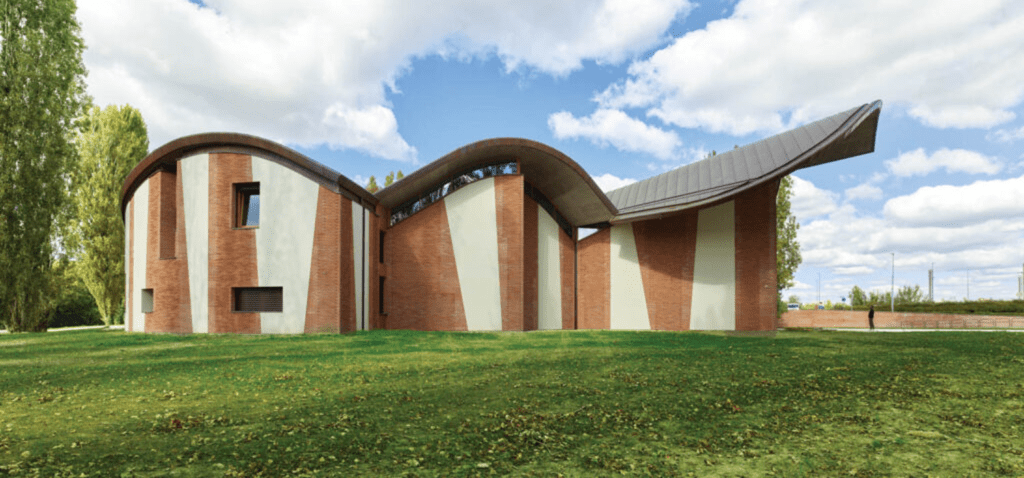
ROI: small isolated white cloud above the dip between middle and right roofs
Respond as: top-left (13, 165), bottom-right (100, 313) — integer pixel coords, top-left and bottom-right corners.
top-left (548, 108), bottom-right (682, 160)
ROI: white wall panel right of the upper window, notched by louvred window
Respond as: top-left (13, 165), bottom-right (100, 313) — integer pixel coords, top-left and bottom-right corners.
top-left (252, 156), bottom-right (319, 334)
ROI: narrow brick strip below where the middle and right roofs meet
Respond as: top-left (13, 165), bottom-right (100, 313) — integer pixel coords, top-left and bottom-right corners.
top-left (577, 228), bottom-right (611, 329)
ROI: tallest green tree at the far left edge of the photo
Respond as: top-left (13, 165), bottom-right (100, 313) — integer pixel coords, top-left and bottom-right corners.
top-left (0, 0), bottom-right (88, 331)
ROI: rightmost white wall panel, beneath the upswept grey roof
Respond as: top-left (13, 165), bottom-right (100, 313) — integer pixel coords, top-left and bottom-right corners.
top-left (690, 201), bottom-right (736, 331)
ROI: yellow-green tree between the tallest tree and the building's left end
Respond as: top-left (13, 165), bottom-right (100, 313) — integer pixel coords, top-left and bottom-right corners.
top-left (65, 104), bottom-right (150, 325)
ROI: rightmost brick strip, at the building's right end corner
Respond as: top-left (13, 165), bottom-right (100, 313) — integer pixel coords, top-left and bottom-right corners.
top-left (735, 181), bottom-right (778, 331)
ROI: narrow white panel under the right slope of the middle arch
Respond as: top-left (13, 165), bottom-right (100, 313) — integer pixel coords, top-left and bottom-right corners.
top-left (537, 207), bottom-right (562, 331)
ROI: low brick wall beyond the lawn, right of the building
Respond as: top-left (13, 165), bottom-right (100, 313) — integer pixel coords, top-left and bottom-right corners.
top-left (778, 310), bottom-right (1024, 329)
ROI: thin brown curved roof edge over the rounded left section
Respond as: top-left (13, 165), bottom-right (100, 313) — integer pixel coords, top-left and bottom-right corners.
top-left (121, 133), bottom-right (377, 218)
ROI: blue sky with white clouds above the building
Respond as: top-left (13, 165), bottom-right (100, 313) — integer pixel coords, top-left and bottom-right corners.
top-left (78, 0), bottom-right (1024, 303)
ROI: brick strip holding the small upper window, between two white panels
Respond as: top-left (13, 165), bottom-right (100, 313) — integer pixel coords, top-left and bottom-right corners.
top-left (207, 153), bottom-right (260, 334)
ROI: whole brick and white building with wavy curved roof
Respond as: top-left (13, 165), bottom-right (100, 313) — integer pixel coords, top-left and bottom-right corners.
top-left (121, 101), bottom-right (881, 334)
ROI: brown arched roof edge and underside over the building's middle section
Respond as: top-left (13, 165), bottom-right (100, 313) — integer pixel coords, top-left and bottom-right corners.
top-left (376, 138), bottom-right (617, 226)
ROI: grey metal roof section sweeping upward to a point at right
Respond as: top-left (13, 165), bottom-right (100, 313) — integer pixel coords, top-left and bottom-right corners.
top-left (607, 101), bottom-right (882, 223)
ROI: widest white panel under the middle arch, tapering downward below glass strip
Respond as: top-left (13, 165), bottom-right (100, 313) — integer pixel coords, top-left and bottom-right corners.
top-left (444, 178), bottom-right (502, 331)
